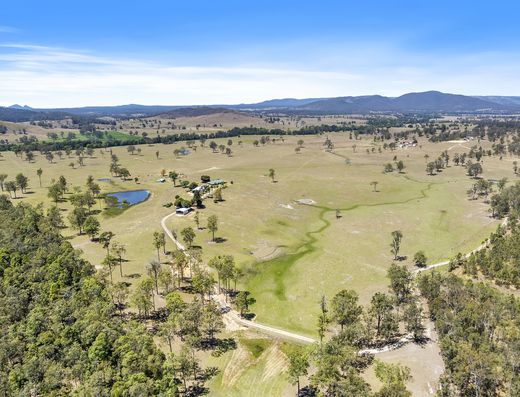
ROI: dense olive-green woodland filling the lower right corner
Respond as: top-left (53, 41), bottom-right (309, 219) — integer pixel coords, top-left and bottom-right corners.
top-left (419, 272), bottom-right (520, 397)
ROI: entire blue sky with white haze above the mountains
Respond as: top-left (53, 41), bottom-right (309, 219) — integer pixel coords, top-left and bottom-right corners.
top-left (0, 0), bottom-right (520, 107)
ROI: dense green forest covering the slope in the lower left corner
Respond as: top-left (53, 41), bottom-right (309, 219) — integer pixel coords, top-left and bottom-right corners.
top-left (0, 196), bottom-right (175, 396)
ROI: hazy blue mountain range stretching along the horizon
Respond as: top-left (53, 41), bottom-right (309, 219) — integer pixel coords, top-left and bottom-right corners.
top-left (0, 91), bottom-right (520, 121)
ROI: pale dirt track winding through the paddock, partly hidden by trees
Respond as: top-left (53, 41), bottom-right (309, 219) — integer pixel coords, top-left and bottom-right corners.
top-left (161, 212), bottom-right (507, 348)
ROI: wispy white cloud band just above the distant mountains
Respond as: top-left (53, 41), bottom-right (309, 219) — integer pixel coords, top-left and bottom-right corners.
top-left (0, 44), bottom-right (520, 107)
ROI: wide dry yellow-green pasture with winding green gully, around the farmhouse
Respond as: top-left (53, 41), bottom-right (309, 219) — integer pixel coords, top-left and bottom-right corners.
top-left (0, 134), bottom-right (513, 336)
